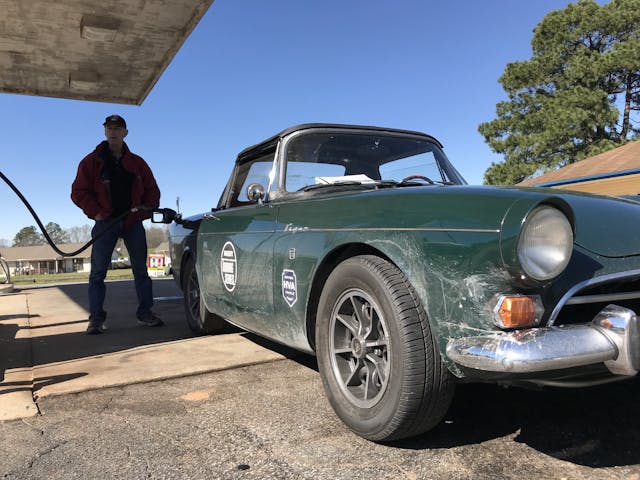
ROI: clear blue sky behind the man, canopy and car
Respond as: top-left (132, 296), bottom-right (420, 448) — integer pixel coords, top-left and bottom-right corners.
top-left (0, 0), bottom-right (592, 244)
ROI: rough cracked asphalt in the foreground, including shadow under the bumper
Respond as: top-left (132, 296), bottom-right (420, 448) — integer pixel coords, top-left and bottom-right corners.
top-left (0, 356), bottom-right (640, 480)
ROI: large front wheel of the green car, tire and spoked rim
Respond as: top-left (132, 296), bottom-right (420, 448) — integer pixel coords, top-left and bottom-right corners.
top-left (316, 255), bottom-right (455, 441)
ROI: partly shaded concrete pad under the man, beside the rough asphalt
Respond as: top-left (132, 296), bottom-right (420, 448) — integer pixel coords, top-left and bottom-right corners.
top-left (0, 279), bottom-right (285, 420)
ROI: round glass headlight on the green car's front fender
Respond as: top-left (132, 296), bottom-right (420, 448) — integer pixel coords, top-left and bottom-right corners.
top-left (518, 205), bottom-right (573, 280)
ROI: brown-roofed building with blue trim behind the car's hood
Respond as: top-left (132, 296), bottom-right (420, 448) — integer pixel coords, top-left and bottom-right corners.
top-left (518, 140), bottom-right (640, 196)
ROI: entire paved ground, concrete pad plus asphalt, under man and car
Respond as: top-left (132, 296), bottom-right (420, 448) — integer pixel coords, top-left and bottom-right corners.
top-left (0, 280), bottom-right (640, 480)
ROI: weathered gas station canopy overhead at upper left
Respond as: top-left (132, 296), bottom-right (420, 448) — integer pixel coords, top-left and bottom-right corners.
top-left (0, 0), bottom-right (213, 105)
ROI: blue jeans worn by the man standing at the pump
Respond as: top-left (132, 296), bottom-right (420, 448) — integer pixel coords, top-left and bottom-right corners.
top-left (89, 220), bottom-right (153, 321)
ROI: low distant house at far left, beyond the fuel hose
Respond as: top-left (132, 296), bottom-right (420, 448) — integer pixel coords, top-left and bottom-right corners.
top-left (0, 243), bottom-right (91, 275)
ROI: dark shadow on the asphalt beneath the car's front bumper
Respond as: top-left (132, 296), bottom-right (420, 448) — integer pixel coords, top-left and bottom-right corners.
top-left (394, 379), bottom-right (640, 468)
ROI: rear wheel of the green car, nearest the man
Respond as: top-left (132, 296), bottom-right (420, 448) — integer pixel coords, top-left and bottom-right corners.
top-left (182, 258), bottom-right (227, 335)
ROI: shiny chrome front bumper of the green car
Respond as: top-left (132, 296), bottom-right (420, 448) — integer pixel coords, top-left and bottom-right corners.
top-left (447, 305), bottom-right (640, 376)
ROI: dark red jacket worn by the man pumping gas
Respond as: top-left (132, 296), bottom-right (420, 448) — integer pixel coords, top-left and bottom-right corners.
top-left (71, 141), bottom-right (160, 229)
